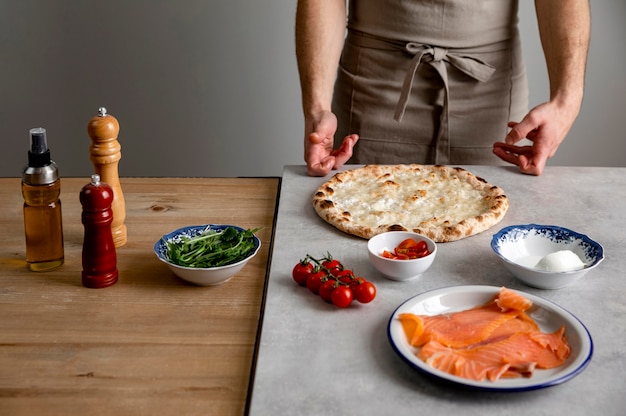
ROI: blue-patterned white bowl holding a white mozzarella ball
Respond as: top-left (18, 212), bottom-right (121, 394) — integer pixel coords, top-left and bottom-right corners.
top-left (491, 224), bottom-right (604, 289)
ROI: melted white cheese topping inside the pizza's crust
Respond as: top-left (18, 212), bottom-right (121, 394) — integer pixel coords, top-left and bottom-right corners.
top-left (333, 173), bottom-right (489, 227)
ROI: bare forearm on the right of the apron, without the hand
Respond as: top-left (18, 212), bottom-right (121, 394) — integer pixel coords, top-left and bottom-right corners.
top-left (535, 0), bottom-right (591, 112)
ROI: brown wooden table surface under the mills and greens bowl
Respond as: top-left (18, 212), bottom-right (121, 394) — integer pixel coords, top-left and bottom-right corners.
top-left (0, 178), bottom-right (280, 416)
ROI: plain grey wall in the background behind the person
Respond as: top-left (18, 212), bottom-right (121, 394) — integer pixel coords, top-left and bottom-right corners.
top-left (0, 0), bottom-right (626, 177)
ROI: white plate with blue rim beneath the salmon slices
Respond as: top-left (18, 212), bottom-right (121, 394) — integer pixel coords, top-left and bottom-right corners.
top-left (387, 286), bottom-right (593, 391)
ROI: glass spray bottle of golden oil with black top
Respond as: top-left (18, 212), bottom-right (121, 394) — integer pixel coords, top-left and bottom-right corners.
top-left (22, 128), bottom-right (64, 272)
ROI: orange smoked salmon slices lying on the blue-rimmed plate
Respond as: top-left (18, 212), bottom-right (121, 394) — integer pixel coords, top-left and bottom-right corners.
top-left (398, 288), bottom-right (570, 381)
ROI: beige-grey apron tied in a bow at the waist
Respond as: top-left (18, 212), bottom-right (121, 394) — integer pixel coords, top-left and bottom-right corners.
top-left (333, 0), bottom-right (528, 164)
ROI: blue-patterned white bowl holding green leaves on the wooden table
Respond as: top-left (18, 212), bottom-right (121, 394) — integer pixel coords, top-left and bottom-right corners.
top-left (154, 224), bottom-right (261, 286)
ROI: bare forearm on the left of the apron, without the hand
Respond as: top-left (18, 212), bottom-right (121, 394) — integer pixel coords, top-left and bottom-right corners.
top-left (296, 0), bottom-right (346, 115)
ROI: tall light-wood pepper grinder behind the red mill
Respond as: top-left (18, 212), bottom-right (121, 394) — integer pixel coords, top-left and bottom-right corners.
top-left (87, 107), bottom-right (127, 247)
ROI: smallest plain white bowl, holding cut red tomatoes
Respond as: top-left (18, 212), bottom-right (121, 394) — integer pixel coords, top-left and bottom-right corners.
top-left (367, 231), bottom-right (437, 281)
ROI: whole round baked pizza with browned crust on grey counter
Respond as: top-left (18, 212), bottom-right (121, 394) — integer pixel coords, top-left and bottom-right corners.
top-left (313, 164), bottom-right (509, 243)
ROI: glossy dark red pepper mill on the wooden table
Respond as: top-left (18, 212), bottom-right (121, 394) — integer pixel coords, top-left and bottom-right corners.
top-left (79, 174), bottom-right (118, 289)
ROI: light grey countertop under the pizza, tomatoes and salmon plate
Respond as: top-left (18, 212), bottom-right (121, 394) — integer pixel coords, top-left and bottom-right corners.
top-left (249, 166), bottom-right (626, 415)
